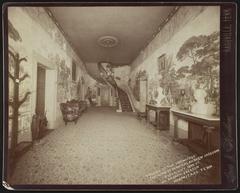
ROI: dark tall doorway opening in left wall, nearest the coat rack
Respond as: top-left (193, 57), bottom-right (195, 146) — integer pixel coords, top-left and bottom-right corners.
top-left (36, 64), bottom-right (46, 115)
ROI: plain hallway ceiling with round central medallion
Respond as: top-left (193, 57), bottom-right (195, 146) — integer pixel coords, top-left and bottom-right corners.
top-left (49, 6), bottom-right (174, 65)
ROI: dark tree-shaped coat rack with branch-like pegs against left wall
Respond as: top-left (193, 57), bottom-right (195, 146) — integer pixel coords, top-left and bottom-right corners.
top-left (8, 50), bottom-right (30, 153)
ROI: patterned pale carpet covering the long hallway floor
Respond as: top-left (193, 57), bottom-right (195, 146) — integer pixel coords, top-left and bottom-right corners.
top-left (11, 107), bottom-right (219, 184)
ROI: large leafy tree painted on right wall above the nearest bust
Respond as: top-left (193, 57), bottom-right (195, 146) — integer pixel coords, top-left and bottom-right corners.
top-left (177, 32), bottom-right (219, 115)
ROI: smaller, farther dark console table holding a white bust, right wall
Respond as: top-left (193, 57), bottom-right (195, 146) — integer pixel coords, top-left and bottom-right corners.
top-left (146, 104), bottom-right (171, 129)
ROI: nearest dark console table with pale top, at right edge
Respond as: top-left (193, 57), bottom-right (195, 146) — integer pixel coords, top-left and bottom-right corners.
top-left (171, 109), bottom-right (220, 154)
